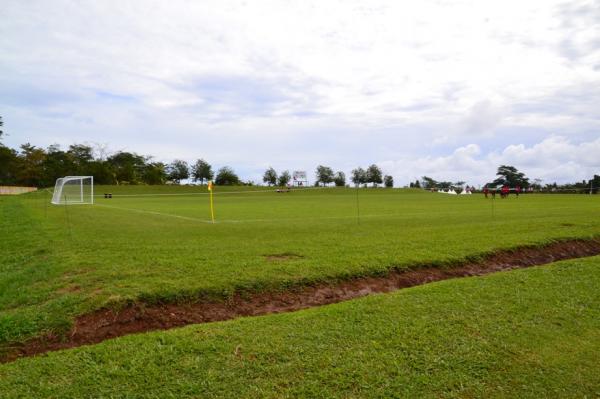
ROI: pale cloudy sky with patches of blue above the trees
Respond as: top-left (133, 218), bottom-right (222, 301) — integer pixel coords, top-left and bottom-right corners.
top-left (0, 0), bottom-right (600, 185)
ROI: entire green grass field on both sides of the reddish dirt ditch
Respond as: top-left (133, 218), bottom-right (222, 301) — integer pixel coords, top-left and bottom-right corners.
top-left (0, 186), bottom-right (600, 396)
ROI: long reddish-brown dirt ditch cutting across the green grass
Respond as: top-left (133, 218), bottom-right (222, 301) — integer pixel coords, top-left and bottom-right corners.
top-left (0, 239), bottom-right (600, 362)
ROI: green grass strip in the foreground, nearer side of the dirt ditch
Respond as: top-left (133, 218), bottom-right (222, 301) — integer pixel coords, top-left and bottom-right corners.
top-left (0, 256), bottom-right (600, 398)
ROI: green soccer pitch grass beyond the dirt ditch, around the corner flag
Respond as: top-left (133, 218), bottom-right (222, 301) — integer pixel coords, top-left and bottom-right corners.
top-left (0, 186), bottom-right (600, 346)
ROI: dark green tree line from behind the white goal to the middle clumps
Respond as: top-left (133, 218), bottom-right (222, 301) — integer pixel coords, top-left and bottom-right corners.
top-left (0, 138), bottom-right (394, 187)
